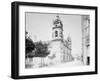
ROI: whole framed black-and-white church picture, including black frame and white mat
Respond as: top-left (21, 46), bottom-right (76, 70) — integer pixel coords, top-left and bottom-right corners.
top-left (12, 2), bottom-right (97, 78)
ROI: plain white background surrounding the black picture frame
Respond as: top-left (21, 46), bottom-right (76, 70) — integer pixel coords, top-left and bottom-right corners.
top-left (0, 0), bottom-right (100, 81)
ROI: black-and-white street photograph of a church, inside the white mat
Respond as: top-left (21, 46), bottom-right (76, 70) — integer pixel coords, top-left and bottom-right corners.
top-left (25, 12), bottom-right (90, 69)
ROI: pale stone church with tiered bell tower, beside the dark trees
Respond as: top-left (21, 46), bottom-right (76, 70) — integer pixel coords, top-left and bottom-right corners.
top-left (45, 16), bottom-right (73, 65)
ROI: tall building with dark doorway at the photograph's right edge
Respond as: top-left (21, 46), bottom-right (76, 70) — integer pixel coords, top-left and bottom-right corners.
top-left (82, 15), bottom-right (90, 65)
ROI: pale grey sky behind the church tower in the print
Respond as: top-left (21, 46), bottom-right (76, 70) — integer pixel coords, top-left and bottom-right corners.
top-left (25, 12), bottom-right (82, 55)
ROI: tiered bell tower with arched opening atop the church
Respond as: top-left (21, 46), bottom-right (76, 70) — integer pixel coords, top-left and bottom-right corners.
top-left (52, 15), bottom-right (63, 40)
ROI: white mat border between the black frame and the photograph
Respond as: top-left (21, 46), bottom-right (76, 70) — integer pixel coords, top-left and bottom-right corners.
top-left (19, 5), bottom-right (95, 76)
